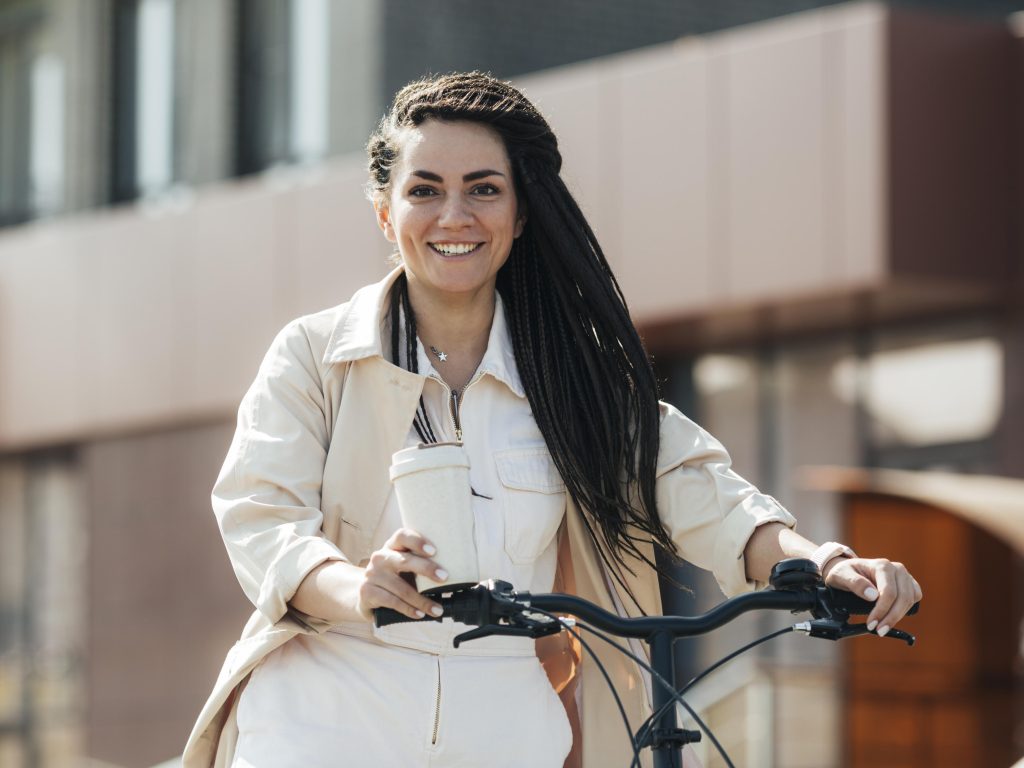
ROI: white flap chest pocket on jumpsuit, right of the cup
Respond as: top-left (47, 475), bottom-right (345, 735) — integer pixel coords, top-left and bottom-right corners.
top-left (495, 447), bottom-right (565, 564)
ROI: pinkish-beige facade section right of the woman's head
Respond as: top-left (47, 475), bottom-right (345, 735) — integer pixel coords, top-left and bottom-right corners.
top-left (521, 4), bottom-right (887, 323)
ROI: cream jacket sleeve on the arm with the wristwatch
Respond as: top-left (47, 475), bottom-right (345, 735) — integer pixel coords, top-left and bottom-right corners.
top-left (655, 402), bottom-right (797, 597)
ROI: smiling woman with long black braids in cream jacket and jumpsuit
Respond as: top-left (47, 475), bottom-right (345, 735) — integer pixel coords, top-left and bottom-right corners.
top-left (185, 73), bottom-right (921, 766)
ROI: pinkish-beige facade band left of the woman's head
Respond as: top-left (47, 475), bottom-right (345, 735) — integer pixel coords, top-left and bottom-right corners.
top-left (0, 161), bottom-right (389, 449)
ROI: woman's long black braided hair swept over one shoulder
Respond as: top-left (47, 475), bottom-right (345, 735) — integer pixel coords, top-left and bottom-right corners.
top-left (367, 72), bottom-right (676, 607)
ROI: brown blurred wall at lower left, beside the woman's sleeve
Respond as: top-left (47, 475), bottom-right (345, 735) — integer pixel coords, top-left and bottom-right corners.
top-left (81, 423), bottom-right (245, 766)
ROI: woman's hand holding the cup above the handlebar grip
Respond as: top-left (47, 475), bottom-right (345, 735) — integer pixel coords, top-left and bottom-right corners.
top-left (357, 528), bottom-right (447, 621)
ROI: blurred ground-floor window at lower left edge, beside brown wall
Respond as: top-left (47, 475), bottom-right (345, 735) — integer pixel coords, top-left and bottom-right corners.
top-left (0, 454), bottom-right (85, 766)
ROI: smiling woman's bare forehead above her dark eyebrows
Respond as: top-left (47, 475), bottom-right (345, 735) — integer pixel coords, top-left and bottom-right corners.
top-left (398, 120), bottom-right (509, 176)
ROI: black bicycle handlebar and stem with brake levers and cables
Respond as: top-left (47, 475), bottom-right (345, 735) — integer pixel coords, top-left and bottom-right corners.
top-left (374, 558), bottom-right (921, 768)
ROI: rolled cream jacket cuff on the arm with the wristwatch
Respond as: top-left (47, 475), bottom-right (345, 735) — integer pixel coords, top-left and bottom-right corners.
top-left (714, 494), bottom-right (797, 597)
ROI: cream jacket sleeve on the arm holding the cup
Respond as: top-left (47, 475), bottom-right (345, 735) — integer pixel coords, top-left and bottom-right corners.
top-left (213, 321), bottom-right (347, 627)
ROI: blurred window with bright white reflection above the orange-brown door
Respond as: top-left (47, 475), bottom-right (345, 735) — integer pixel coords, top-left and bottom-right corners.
top-left (694, 318), bottom-right (1004, 487)
